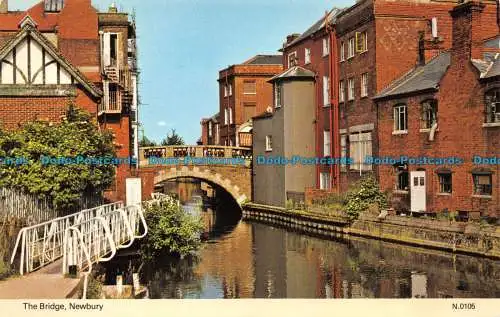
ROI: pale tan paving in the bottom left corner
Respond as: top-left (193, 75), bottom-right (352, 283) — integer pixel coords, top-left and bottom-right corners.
top-left (0, 260), bottom-right (80, 299)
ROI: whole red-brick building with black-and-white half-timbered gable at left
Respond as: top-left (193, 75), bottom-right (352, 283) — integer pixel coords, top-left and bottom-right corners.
top-left (0, 0), bottom-right (138, 199)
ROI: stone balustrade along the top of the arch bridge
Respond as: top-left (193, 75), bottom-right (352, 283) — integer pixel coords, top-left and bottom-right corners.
top-left (139, 145), bottom-right (252, 165)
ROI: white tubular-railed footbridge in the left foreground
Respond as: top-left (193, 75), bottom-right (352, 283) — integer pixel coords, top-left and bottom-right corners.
top-left (11, 196), bottom-right (161, 298)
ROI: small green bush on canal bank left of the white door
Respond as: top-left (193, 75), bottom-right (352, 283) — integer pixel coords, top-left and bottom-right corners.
top-left (345, 177), bottom-right (388, 220)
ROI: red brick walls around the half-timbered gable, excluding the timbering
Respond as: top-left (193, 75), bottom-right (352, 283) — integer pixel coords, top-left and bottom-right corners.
top-left (0, 0), bottom-right (137, 200)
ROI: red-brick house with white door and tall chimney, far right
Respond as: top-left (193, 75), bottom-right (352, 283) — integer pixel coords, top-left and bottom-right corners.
top-left (375, 1), bottom-right (500, 217)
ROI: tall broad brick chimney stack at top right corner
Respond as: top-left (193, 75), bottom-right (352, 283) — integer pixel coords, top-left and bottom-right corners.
top-left (450, 1), bottom-right (485, 64)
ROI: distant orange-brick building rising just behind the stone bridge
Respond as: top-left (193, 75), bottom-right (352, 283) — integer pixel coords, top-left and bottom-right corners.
top-left (217, 55), bottom-right (282, 146)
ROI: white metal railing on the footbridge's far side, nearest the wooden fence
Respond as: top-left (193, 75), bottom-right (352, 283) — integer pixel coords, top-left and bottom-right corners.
top-left (11, 202), bottom-right (123, 275)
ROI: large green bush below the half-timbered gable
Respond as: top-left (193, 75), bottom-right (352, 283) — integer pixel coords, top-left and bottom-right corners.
top-left (0, 106), bottom-right (115, 210)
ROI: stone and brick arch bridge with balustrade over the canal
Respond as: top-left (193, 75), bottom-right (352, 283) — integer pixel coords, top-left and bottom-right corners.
top-left (139, 146), bottom-right (252, 206)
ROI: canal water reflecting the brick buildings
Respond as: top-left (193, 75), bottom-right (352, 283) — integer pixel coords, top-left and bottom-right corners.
top-left (102, 180), bottom-right (500, 299)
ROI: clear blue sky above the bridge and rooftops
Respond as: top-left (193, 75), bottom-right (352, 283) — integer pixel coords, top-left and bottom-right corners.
top-left (9, 0), bottom-right (355, 144)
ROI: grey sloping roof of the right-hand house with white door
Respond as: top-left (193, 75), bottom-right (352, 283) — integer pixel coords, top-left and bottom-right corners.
top-left (374, 52), bottom-right (450, 99)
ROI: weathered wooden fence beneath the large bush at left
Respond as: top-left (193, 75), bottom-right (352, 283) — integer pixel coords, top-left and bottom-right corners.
top-left (0, 188), bottom-right (104, 225)
